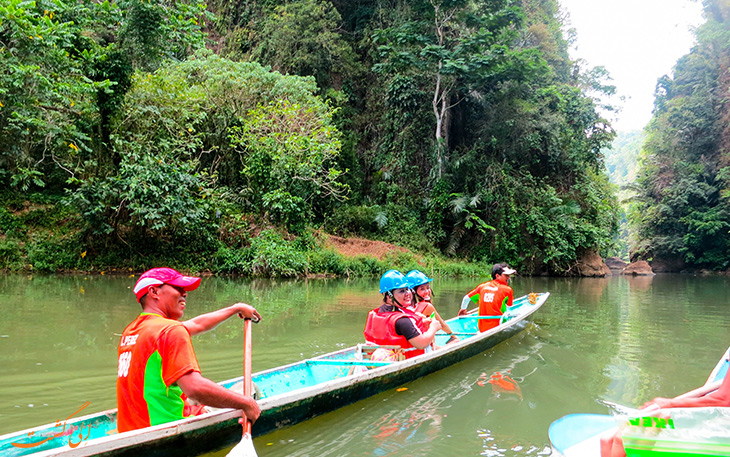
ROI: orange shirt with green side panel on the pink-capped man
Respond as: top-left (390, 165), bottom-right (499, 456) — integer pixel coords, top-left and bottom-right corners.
top-left (117, 313), bottom-right (200, 433)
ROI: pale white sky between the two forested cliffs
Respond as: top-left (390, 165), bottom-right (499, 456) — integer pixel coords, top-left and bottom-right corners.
top-left (558, 0), bottom-right (704, 131)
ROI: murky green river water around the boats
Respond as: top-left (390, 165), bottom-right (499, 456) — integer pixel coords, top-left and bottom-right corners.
top-left (0, 275), bottom-right (730, 457)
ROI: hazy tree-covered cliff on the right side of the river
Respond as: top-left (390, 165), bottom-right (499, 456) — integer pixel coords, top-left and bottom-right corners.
top-left (630, 0), bottom-right (730, 271)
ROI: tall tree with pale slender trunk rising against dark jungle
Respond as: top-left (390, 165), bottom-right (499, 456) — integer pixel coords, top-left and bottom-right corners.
top-left (373, 0), bottom-right (519, 179)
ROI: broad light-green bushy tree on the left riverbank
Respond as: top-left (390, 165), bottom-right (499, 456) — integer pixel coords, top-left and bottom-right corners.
top-left (73, 54), bottom-right (346, 237)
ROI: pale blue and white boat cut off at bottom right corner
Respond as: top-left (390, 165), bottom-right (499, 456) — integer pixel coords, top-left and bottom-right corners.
top-left (548, 348), bottom-right (730, 457)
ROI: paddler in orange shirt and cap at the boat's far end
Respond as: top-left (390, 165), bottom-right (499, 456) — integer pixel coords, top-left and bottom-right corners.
top-left (458, 263), bottom-right (515, 332)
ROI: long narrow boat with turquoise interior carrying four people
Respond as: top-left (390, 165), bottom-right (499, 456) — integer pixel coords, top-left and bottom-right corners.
top-left (0, 292), bottom-right (550, 457)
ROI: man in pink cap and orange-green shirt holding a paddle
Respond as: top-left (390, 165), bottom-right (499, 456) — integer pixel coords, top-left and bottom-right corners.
top-left (117, 268), bottom-right (261, 433)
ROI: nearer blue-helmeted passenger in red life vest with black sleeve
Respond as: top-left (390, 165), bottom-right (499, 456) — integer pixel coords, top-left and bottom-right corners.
top-left (363, 270), bottom-right (441, 358)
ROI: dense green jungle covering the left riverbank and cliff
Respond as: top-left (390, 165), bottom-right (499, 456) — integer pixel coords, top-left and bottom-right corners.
top-left (0, 0), bottom-right (620, 276)
